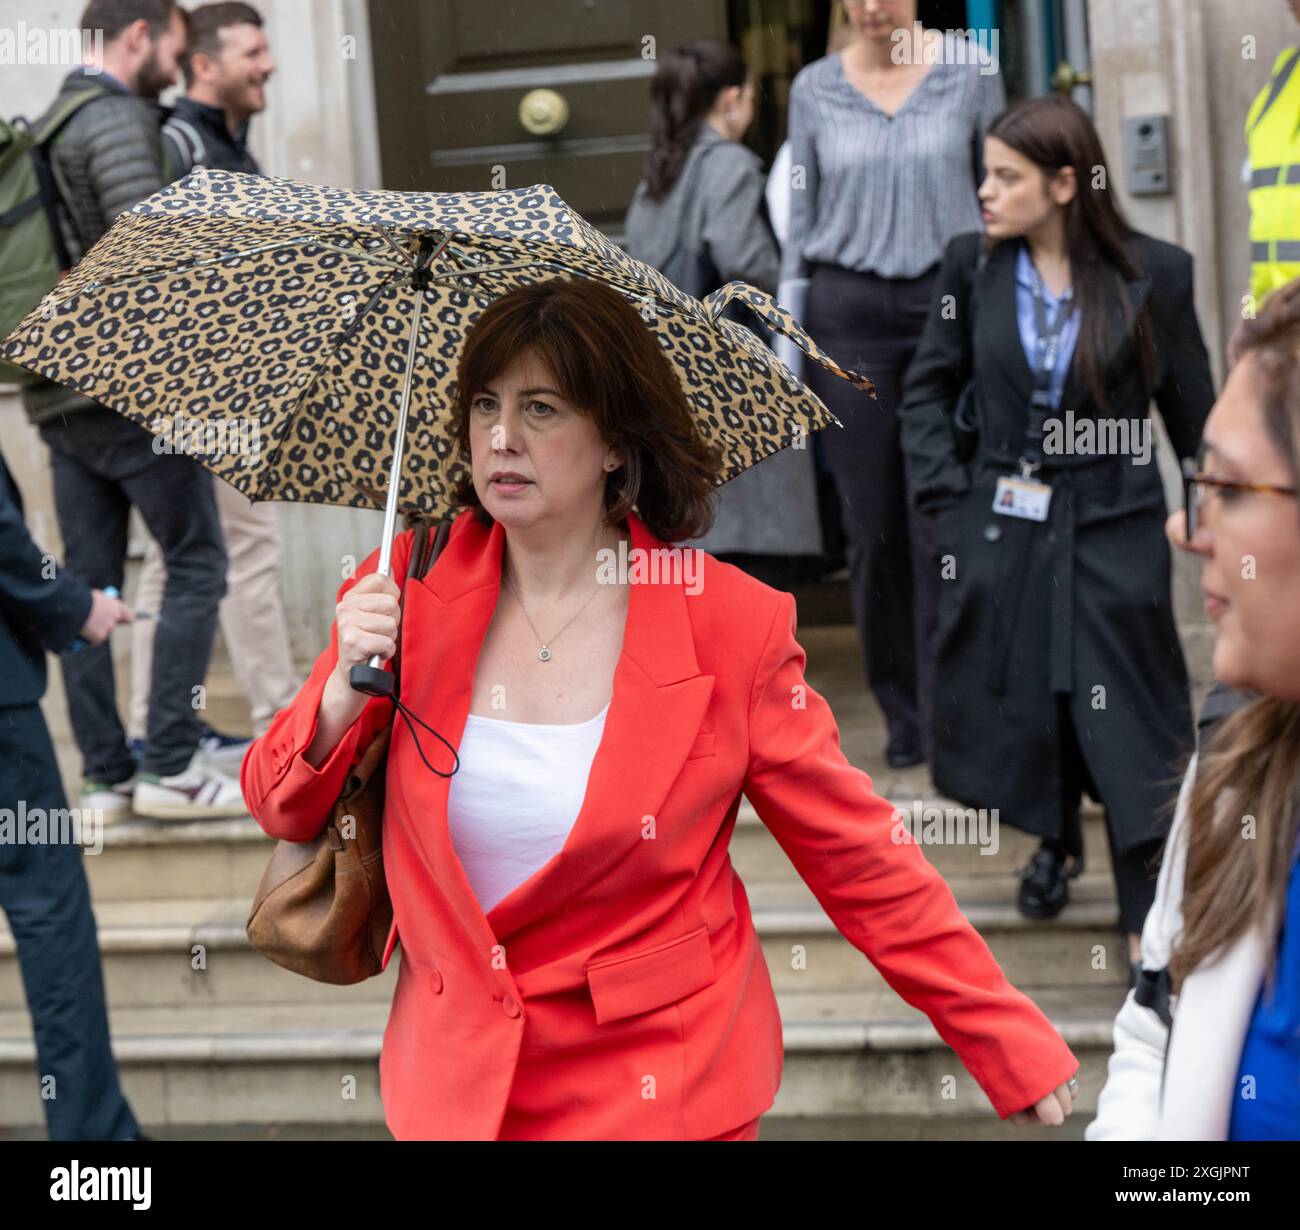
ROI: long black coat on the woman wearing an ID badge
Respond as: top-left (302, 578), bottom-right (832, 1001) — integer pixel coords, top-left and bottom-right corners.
top-left (901, 234), bottom-right (1214, 850)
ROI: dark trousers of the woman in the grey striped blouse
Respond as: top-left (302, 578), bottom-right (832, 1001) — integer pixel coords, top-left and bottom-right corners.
top-left (805, 264), bottom-right (939, 757)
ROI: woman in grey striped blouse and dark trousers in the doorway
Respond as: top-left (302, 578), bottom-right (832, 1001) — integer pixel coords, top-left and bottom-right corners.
top-left (781, 0), bottom-right (1005, 767)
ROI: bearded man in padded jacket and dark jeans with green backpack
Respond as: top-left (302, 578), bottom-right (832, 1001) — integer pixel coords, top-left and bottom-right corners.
top-left (23, 0), bottom-right (244, 819)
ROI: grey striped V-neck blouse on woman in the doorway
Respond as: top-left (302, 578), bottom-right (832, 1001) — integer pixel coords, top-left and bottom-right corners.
top-left (781, 34), bottom-right (1006, 280)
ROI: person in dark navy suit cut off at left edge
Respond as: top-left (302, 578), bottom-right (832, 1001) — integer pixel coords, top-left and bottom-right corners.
top-left (0, 444), bottom-right (140, 1140)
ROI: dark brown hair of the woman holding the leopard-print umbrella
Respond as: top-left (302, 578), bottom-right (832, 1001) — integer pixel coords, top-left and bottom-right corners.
top-left (452, 277), bottom-right (723, 542)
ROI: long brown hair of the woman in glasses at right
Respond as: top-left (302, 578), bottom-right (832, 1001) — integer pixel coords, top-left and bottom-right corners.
top-left (1169, 278), bottom-right (1300, 989)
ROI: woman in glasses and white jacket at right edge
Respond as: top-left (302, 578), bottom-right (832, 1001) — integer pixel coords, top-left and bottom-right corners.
top-left (1087, 280), bottom-right (1300, 1140)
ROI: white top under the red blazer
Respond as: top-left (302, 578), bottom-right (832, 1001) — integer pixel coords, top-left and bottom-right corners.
top-left (447, 705), bottom-right (610, 914)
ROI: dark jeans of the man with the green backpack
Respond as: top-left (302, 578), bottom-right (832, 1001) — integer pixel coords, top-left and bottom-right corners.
top-left (40, 407), bottom-right (226, 783)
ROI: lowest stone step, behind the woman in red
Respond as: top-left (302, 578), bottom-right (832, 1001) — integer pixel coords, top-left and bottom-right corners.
top-left (0, 988), bottom-right (1122, 1134)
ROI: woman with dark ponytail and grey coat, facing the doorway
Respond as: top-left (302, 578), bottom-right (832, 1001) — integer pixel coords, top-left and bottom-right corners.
top-left (624, 39), bottom-right (822, 588)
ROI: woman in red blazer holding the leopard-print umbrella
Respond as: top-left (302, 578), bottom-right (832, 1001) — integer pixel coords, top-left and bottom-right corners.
top-left (242, 280), bottom-right (1078, 1140)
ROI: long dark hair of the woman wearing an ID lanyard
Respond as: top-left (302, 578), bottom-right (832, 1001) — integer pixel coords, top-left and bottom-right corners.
top-left (985, 94), bottom-right (1159, 410)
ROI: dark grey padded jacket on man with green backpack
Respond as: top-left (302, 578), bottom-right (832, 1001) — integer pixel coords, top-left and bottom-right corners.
top-left (23, 68), bottom-right (166, 424)
